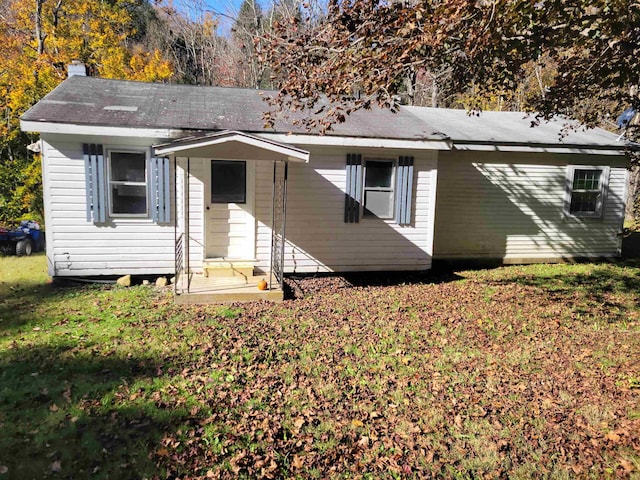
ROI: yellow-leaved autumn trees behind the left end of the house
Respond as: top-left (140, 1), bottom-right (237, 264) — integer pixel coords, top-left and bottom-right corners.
top-left (0, 0), bottom-right (172, 221)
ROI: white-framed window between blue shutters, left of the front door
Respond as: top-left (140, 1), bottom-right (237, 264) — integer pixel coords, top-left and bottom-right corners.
top-left (109, 151), bottom-right (148, 216)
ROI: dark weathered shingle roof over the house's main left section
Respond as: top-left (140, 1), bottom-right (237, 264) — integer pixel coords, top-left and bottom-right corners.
top-left (22, 76), bottom-right (441, 140)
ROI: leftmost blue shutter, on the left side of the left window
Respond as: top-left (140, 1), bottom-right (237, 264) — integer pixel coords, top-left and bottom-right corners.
top-left (82, 143), bottom-right (107, 223)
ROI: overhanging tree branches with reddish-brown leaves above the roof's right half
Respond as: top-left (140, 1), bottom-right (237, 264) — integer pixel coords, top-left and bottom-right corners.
top-left (268, 0), bottom-right (640, 129)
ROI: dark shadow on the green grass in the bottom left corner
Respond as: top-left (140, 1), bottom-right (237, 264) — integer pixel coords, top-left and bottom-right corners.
top-left (0, 342), bottom-right (188, 478)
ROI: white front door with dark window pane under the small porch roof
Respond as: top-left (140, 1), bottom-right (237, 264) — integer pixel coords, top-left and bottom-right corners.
top-left (204, 160), bottom-right (256, 260)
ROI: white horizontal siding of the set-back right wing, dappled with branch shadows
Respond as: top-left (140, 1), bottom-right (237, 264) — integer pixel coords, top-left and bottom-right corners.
top-left (434, 151), bottom-right (627, 263)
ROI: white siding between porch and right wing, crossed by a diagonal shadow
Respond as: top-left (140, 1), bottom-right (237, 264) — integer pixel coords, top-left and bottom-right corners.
top-left (255, 149), bottom-right (437, 273)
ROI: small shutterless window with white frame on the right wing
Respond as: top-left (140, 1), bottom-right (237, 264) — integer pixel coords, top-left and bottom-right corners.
top-left (565, 165), bottom-right (608, 217)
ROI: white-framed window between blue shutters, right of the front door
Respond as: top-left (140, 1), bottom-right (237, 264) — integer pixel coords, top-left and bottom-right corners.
top-left (363, 159), bottom-right (394, 218)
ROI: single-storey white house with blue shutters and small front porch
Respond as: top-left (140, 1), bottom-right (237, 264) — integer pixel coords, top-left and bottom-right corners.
top-left (21, 76), bottom-right (627, 299)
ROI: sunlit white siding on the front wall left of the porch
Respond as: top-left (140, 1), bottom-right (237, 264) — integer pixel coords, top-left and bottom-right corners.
top-left (42, 135), bottom-right (174, 276)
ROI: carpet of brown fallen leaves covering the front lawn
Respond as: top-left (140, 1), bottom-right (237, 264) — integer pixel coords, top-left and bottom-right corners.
top-left (3, 266), bottom-right (640, 479)
